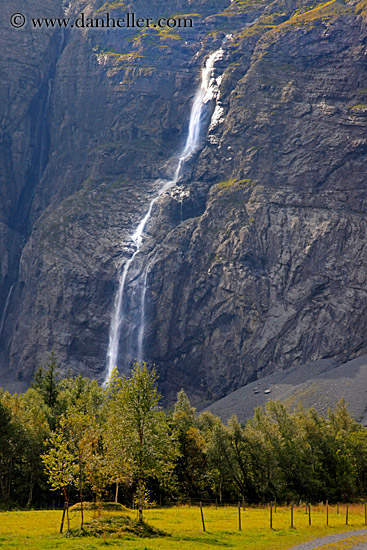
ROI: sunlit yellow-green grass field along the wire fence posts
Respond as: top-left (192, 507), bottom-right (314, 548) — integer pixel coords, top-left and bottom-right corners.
top-left (0, 505), bottom-right (365, 550)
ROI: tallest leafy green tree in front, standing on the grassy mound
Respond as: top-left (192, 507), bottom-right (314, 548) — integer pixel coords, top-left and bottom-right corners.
top-left (107, 363), bottom-right (176, 521)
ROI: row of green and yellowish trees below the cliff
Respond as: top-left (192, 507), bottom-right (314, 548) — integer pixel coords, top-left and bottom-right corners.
top-left (0, 354), bottom-right (367, 524)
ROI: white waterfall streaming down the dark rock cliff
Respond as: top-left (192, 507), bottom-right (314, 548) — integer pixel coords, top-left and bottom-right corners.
top-left (105, 48), bottom-right (223, 383)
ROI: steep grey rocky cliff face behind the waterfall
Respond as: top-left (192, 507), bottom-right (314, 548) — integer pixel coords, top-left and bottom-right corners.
top-left (0, 0), bottom-right (367, 402)
